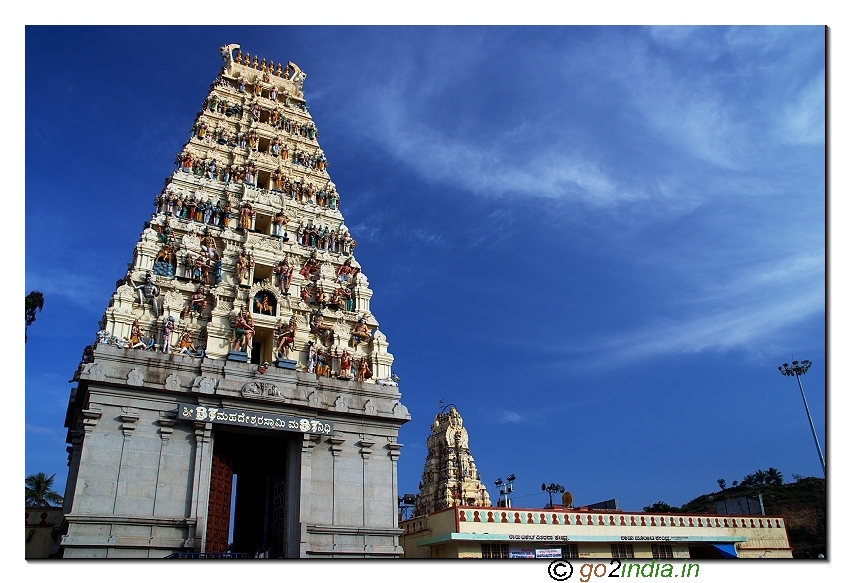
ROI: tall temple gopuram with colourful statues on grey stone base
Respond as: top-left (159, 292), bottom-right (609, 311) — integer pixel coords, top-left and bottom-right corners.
top-left (61, 45), bottom-right (410, 558)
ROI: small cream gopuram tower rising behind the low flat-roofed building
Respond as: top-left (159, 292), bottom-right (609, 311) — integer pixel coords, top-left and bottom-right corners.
top-left (416, 405), bottom-right (492, 516)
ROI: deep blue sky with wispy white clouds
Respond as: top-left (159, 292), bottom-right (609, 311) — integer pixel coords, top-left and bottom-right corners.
top-left (24, 26), bottom-right (830, 532)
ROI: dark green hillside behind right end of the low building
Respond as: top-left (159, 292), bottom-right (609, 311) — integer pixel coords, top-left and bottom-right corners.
top-left (681, 478), bottom-right (826, 559)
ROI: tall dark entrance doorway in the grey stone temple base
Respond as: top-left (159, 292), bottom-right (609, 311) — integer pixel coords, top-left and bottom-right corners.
top-left (205, 428), bottom-right (300, 558)
